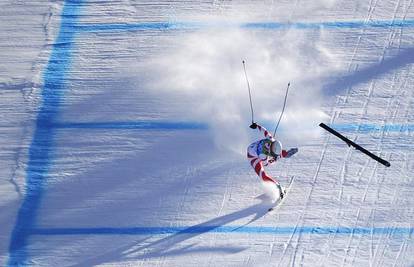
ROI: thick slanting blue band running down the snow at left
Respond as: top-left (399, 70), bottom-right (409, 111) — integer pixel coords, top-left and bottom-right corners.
top-left (8, 0), bottom-right (81, 266)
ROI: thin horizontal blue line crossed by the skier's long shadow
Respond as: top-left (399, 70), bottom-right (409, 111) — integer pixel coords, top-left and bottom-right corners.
top-left (31, 225), bottom-right (414, 235)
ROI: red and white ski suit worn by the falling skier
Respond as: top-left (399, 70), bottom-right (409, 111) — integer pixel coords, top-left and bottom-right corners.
top-left (247, 125), bottom-right (288, 185)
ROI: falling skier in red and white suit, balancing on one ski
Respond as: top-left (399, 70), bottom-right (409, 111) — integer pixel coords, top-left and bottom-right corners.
top-left (247, 122), bottom-right (298, 201)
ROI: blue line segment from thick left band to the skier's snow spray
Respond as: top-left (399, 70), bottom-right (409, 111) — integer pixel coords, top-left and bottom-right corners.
top-left (41, 121), bottom-right (208, 130)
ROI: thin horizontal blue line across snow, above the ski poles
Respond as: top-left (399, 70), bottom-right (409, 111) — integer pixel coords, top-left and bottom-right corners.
top-left (73, 20), bottom-right (414, 32)
